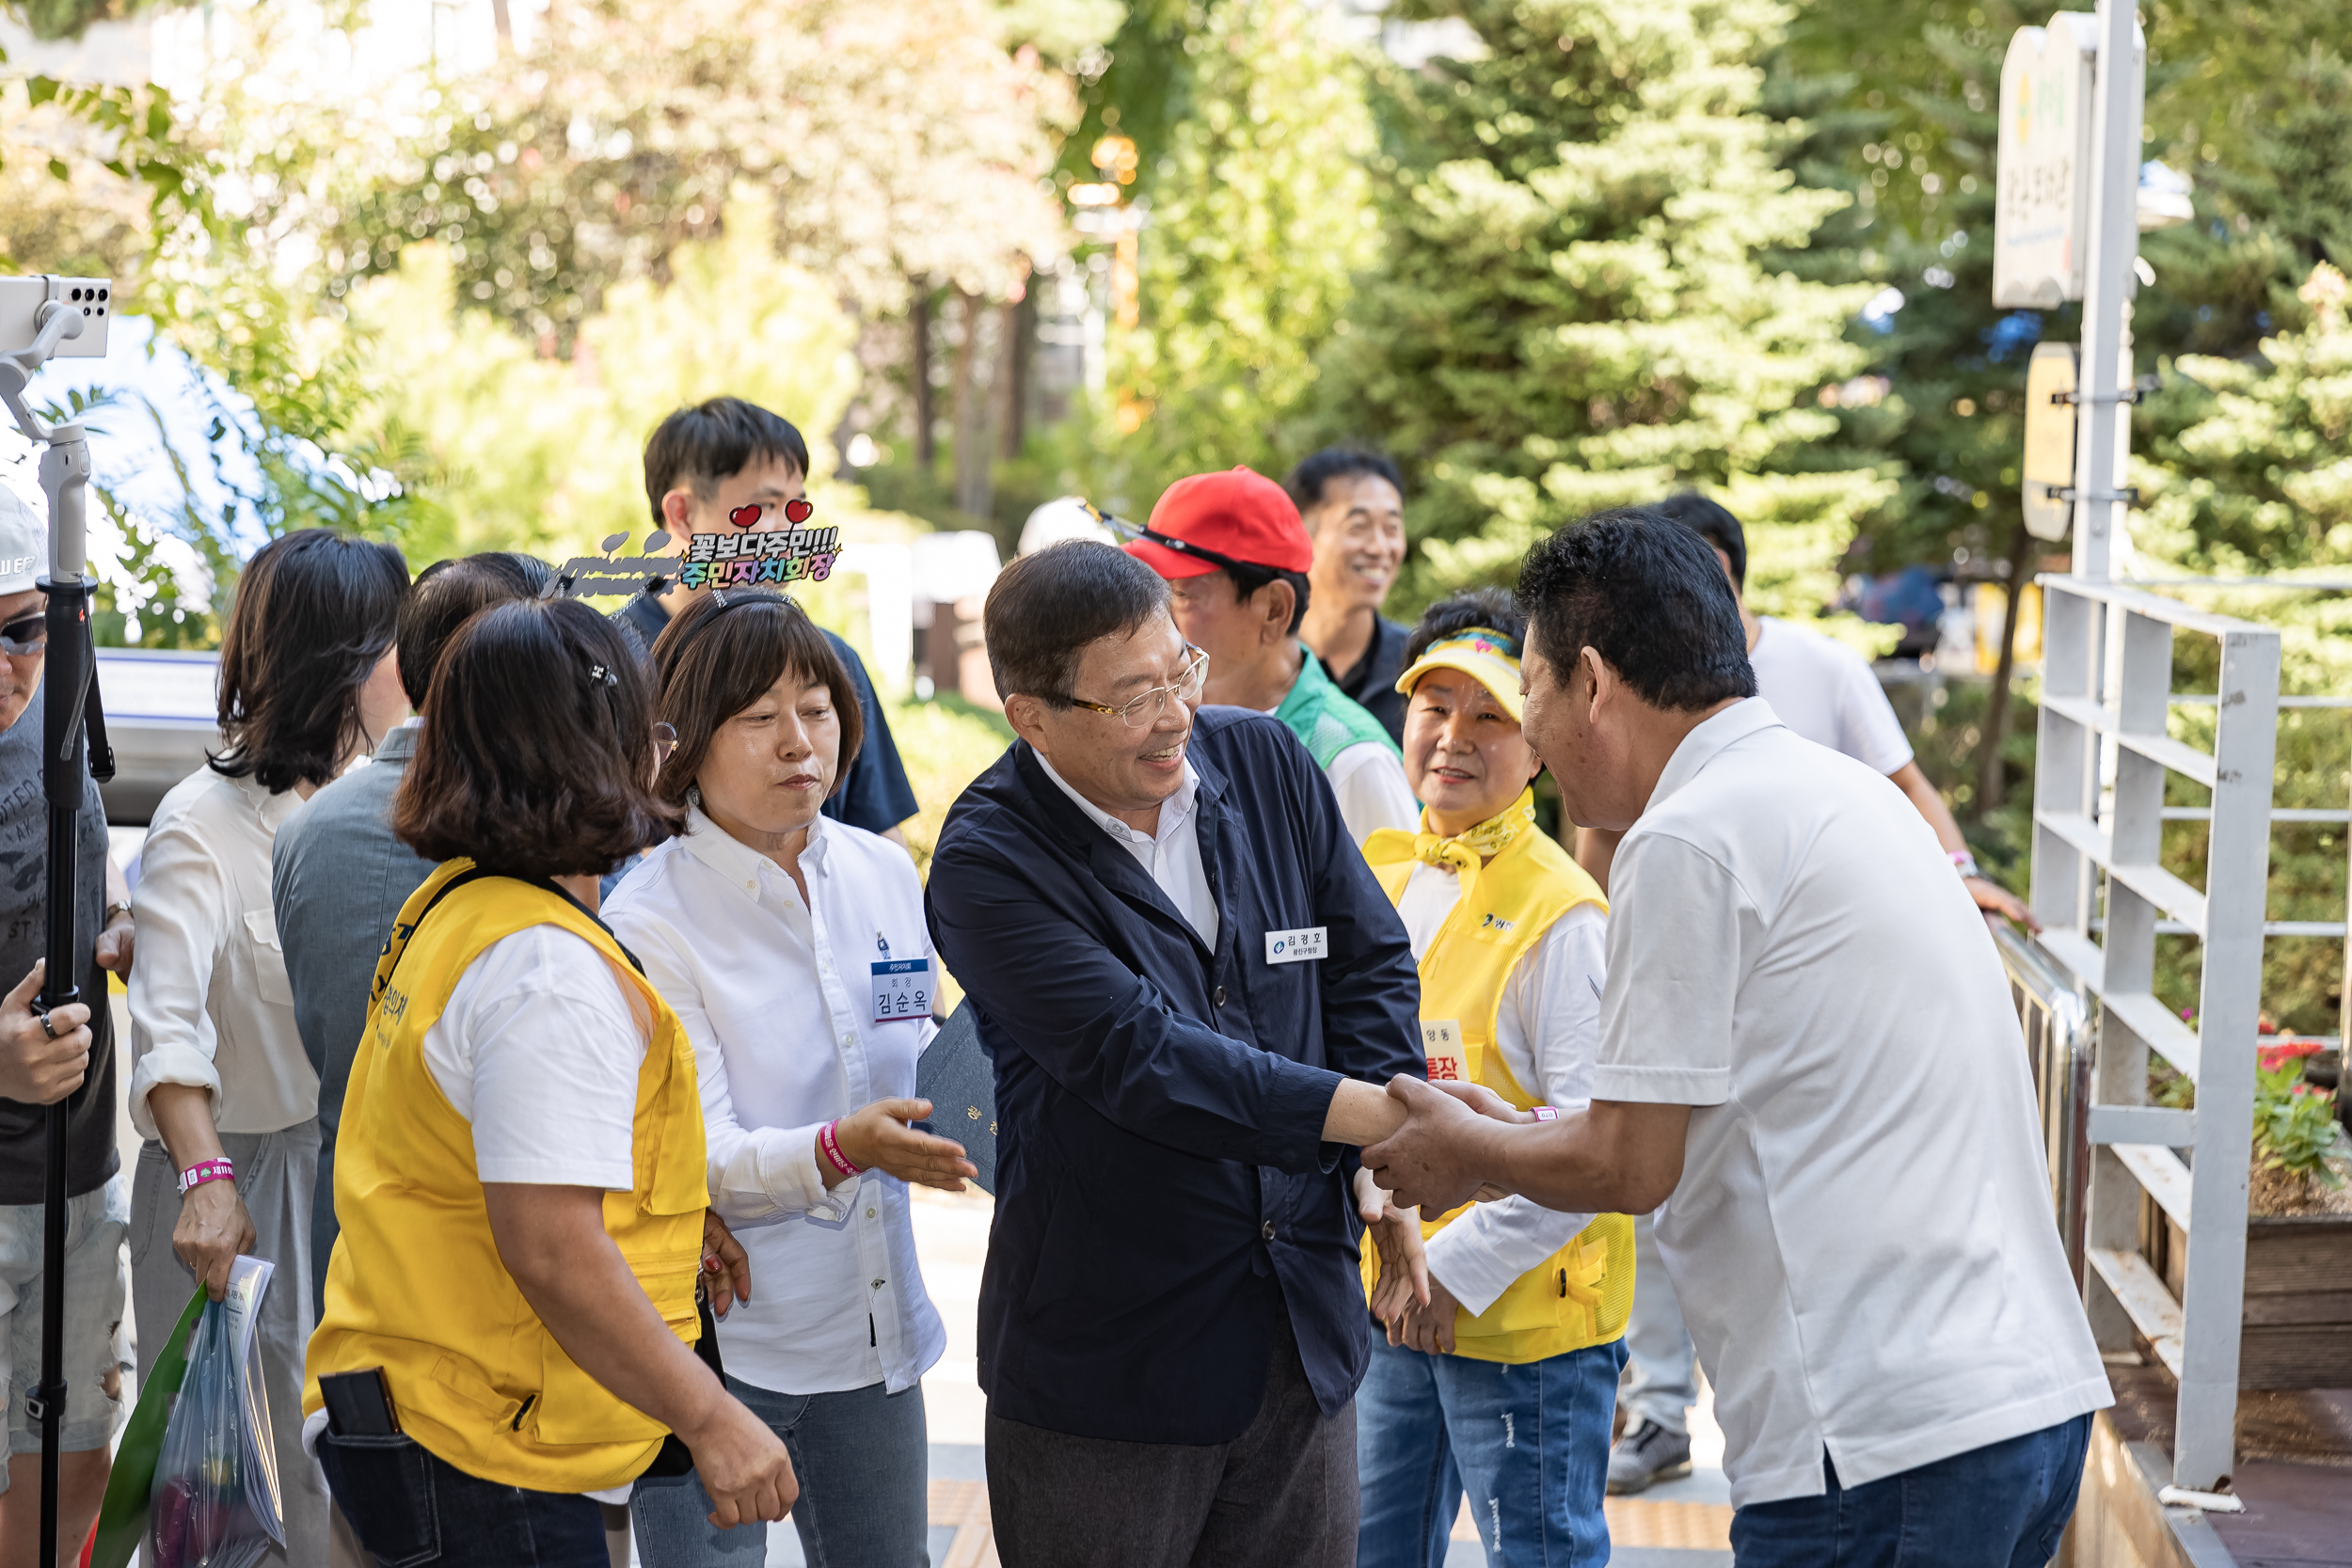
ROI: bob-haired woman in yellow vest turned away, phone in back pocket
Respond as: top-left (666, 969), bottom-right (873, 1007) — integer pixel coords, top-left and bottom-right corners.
top-left (304, 599), bottom-right (795, 1568)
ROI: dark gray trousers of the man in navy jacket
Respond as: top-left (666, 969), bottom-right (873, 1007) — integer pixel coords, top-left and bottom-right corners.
top-left (988, 1319), bottom-right (1358, 1568)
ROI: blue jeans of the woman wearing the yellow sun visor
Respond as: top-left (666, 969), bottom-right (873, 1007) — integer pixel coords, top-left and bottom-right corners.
top-left (1355, 1340), bottom-right (1626, 1568)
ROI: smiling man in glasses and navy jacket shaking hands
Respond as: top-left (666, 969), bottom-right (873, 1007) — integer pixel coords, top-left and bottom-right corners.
top-left (930, 543), bottom-right (1423, 1568)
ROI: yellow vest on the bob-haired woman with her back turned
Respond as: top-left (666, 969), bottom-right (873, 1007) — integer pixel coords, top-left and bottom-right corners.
top-left (304, 861), bottom-right (708, 1493)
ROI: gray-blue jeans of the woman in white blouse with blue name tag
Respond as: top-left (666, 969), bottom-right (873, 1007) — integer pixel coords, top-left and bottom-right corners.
top-left (635, 1378), bottom-right (931, 1568)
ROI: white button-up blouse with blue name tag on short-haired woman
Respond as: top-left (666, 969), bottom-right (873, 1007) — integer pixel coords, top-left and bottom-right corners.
top-left (605, 809), bottom-right (948, 1394)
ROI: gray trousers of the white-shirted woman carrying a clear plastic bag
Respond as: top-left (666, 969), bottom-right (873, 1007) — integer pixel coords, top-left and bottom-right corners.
top-left (132, 1121), bottom-right (331, 1568)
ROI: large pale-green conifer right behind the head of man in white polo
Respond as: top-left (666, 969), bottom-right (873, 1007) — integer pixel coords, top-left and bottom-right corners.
top-left (1325, 0), bottom-right (1889, 613)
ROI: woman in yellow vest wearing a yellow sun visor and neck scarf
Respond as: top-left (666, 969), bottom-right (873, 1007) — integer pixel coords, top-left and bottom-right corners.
top-left (1355, 590), bottom-right (1632, 1568)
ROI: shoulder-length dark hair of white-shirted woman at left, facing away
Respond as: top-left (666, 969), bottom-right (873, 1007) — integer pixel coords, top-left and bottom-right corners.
top-left (210, 529), bottom-right (409, 795)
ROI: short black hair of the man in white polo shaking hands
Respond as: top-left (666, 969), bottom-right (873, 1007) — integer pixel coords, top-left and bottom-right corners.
top-left (1519, 505), bottom-right (1757, 712)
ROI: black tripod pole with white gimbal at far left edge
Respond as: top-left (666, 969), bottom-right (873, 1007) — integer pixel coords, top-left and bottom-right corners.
top-left (0, 285), bottom-right (116, 1566)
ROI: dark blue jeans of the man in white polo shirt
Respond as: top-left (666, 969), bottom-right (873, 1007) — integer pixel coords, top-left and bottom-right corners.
top-left (1731, 1416), bottom-right (2091, 1568)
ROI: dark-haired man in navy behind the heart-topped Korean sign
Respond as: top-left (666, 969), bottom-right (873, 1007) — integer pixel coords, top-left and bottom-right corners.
top-left (616, 397), bottom-right (915, 844)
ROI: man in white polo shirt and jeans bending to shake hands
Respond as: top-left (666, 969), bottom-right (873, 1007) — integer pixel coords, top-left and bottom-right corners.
top-left (1364, 510), bottom-right (2110, 1568)
